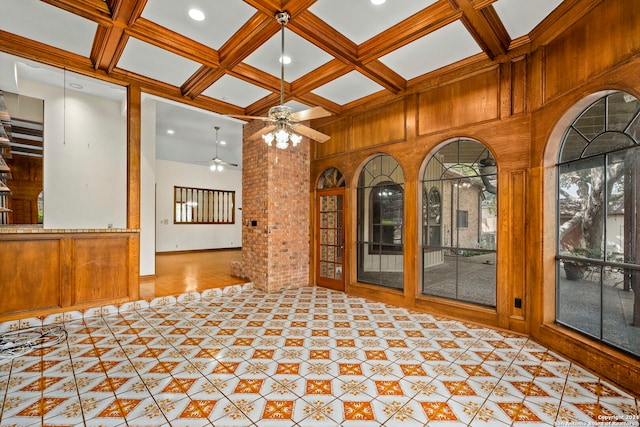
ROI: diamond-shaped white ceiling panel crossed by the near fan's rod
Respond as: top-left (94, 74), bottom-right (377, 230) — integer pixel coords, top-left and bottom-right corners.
top-left (244, 28), bottom-right (332, 82)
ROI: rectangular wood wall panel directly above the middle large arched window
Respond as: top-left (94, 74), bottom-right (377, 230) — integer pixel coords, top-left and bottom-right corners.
top-left (418, 68), bottom-right (500, 135)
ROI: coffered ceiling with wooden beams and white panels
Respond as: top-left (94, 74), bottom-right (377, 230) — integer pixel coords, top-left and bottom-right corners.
top-left (0, 0), bottom-right (580, 167)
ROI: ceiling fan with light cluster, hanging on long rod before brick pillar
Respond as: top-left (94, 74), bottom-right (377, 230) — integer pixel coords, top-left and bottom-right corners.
top-left (231, 12), bottom-right (331, 148)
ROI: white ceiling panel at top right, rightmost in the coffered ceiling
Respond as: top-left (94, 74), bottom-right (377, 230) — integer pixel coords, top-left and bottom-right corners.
top-left (493, 0), bottom-right (562, 39)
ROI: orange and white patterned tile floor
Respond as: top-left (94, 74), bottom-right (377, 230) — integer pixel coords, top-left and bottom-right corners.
top-left (0, 286), bottom-right (639, 427)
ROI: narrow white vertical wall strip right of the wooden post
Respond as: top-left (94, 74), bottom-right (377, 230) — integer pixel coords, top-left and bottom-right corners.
top-left (140, 99), bottom-right (156, 276)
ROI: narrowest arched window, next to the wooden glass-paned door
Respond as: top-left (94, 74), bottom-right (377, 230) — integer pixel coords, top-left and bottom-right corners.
top-left (357, 155), bottom-right (404, 289)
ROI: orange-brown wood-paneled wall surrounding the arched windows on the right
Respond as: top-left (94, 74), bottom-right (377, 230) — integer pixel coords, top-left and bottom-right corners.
top-left (311, 0), bottom-right (640, 392)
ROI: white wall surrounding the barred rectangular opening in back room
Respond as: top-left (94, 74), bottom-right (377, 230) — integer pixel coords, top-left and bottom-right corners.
top-left (156, 160), bottom-right (242, 252)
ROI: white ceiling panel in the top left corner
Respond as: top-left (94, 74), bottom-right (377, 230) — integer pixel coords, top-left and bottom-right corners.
top-left (0, 0), bottom-right (98, 56)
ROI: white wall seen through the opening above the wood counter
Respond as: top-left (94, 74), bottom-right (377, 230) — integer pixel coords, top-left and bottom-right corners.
top-left (20, 80), bottom-right (127, 229)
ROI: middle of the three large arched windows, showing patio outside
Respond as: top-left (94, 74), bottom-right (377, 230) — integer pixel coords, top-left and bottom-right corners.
top-left (422, 139), bottom-right (498, 307)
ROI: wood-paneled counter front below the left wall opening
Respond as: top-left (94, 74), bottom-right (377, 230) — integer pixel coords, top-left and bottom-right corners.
top-left (0, 226), bottom-right (139, 322)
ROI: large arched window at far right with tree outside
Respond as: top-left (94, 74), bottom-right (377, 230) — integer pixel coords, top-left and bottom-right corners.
top-left (556, 92), bottom-right (640, 356)
